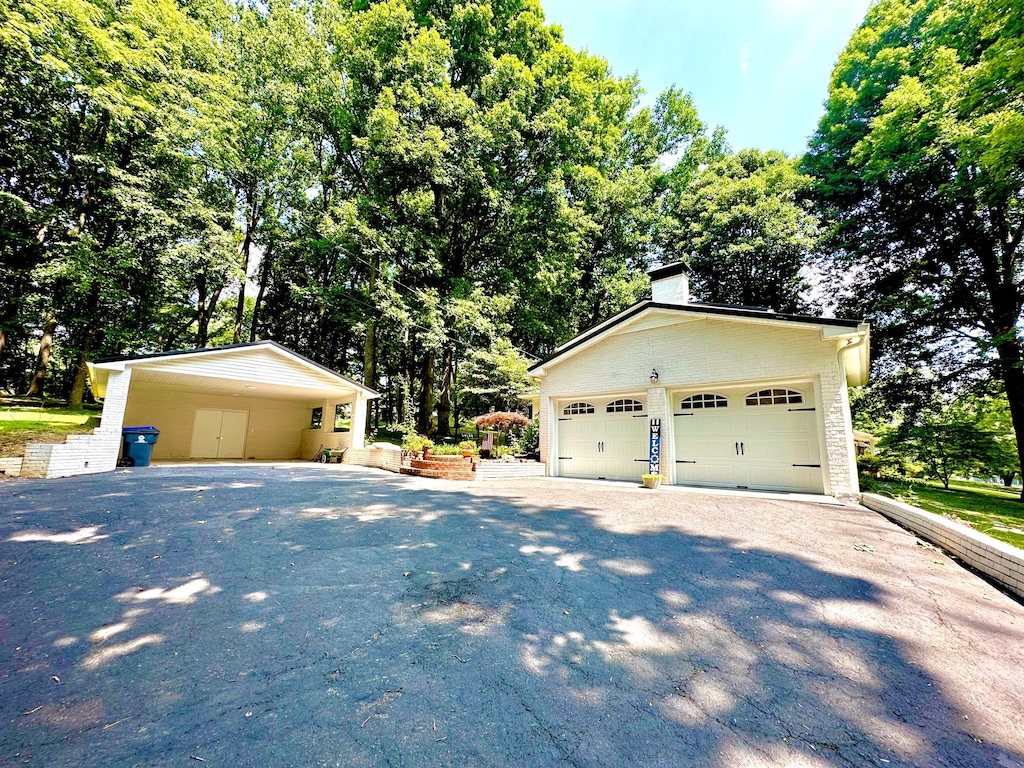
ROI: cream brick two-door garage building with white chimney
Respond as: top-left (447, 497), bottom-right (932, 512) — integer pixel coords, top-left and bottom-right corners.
top-left (530, 263), bottom-right (870, 499)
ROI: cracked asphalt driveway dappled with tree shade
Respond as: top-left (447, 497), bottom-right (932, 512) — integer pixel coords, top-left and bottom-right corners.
top-left (0, 465), bottom-right (1024, 768)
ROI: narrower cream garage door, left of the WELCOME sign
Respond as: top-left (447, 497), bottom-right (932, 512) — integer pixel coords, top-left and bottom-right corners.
top-left (557, 397), bottom-right (649, 481)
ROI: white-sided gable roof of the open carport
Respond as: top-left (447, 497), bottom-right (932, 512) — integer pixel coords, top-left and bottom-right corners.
top-left (89, 341), bottom-right (380, 398)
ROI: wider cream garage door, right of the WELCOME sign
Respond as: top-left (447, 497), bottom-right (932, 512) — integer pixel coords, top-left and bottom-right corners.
top-left (673, 387), bottom-right (824, 494)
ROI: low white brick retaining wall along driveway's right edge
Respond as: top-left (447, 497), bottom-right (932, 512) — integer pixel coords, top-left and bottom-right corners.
top-left (860, 494), bottom-right (1024, 597)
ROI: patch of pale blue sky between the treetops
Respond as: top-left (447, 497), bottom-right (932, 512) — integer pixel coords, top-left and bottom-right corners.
top-left (541, 0), bottom-right (870, 155)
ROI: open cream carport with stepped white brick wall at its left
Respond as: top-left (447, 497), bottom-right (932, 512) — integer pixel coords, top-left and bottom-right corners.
top-left (22, 341), bottom-right (378, 477)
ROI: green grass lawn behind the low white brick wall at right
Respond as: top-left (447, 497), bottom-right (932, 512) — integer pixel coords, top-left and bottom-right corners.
top-left (861, 478), bottom-right (1024, 549)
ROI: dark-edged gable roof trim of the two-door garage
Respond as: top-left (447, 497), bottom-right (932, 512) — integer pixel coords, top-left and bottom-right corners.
top-left (527, 299), bottom-right (870, 386)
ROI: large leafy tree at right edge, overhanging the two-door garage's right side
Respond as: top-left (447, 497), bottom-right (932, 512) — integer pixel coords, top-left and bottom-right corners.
top-left (805, 0), bottom-right (1024, 499)
